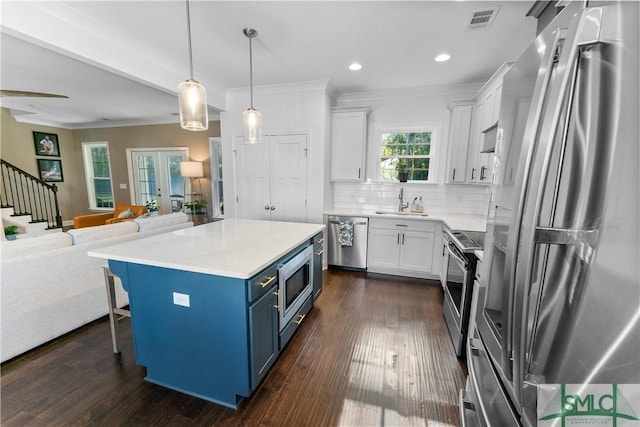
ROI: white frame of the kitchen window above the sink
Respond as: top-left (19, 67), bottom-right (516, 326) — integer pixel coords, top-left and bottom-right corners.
top-left (372, 123), bottom-right (440, 184)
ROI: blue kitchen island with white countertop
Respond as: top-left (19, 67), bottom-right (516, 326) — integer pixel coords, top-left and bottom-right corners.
top-left (89, 219), bottom-right (324, 408)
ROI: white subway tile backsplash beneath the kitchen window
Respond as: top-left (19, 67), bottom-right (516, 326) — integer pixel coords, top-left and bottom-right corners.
top-left (333, 182), bottom-right (491, 216)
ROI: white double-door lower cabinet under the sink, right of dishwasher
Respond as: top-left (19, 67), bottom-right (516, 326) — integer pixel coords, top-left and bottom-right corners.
top-left (367, 218), bottom-right (439, 278)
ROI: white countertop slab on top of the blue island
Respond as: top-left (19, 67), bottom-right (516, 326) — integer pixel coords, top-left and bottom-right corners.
top-left (88, 219), bottom-right (325, 279)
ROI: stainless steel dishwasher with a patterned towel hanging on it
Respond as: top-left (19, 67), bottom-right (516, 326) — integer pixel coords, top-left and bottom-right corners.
top-left (327, 216), bottom-right (369, 270)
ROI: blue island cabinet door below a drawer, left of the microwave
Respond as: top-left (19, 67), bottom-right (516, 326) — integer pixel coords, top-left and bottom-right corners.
top-left (249, 286), bottom-right (278, 390)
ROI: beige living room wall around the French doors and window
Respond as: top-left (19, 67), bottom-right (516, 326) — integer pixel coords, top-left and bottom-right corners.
top-left (0, 108), bottom-right (220, 221)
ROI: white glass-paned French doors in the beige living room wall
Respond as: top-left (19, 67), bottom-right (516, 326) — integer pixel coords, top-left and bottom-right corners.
top-left (127, 148), bottom-right (189, 214)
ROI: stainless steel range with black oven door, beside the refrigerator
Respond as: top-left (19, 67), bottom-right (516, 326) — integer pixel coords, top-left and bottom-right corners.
top-left (442, 229), bottom-right (484, 356)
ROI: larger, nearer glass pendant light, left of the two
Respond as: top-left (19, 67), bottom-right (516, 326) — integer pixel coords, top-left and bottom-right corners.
top-left (178, 0), bottom-right (209, 131)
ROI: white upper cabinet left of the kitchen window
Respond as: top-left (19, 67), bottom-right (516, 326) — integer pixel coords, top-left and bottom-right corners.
top-left (331, 108), bottom-right (368, 182)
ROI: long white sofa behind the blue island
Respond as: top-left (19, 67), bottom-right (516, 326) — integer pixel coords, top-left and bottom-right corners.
top-left (0, 212), bottom-right (193, 362)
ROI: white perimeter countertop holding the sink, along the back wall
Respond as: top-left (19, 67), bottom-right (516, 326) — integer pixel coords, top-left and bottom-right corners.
top-left (324, 208), bottom-right (487, 231)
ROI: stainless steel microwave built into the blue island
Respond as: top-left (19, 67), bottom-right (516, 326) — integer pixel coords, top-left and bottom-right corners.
top-left (278, 245), bottom-right (313, 331)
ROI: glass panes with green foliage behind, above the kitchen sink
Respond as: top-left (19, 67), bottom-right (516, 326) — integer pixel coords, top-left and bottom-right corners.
top-left (380, 132), bottom-right (431, 181)
